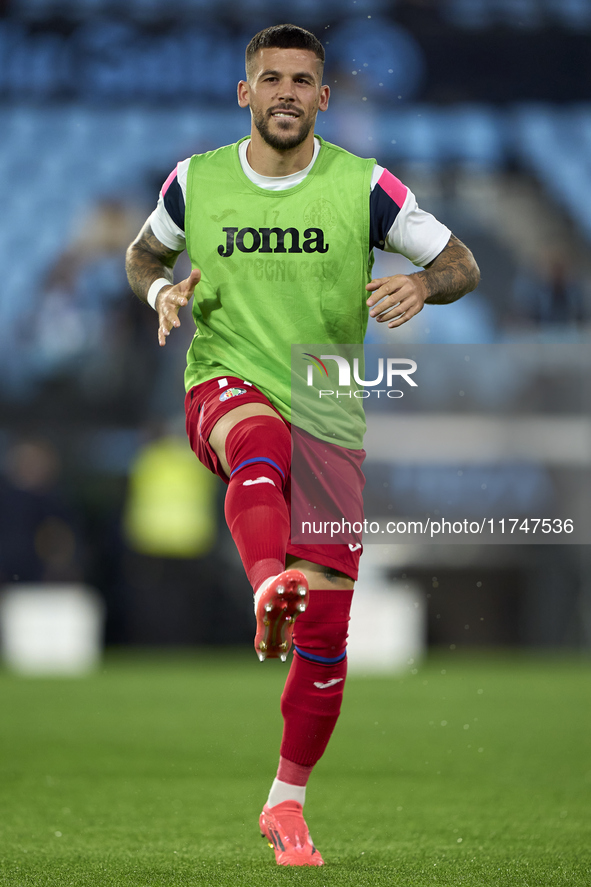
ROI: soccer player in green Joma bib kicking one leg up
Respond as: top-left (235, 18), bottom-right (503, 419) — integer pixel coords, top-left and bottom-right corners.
top-left (127, 25), bottom-right (479, 865)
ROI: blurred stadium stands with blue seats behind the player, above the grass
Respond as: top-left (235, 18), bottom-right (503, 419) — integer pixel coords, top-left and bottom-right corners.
top-left (0, 0), bottom-right (591, 649)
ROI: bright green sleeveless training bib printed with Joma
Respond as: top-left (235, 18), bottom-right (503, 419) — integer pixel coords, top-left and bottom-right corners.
top-left (185, 140), bottom-right (375, 448)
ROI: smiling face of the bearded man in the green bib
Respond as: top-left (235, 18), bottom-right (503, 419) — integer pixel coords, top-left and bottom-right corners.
top-left (238, 48), bottom-right (330, 151)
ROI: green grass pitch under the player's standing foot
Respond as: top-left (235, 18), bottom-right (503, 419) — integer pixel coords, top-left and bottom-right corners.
top-left (0, 651), bottom-right (591, 887)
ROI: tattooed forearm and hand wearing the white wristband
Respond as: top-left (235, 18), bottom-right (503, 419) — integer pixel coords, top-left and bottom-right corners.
top-left (125, 222), bottom-right (201, 345)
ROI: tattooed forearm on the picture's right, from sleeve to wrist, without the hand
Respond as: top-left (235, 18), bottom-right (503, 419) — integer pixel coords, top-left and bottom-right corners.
top-left (418, 234), bottom-right (480, 305)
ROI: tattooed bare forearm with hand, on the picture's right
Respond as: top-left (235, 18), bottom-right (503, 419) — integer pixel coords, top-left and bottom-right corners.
top-left (366, 234), bottom-right (480, 327)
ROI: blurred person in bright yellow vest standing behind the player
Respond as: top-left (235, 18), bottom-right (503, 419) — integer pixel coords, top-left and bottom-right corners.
top-left (122, 433), bottom-right (252, 645)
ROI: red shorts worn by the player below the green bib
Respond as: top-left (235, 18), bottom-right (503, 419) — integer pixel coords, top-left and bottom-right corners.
top-left (185, 376), bottom-right (365, 579)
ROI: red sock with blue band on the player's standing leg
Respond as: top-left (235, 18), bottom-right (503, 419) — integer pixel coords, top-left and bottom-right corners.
top-left (279, 589), bottom-right (353, 768)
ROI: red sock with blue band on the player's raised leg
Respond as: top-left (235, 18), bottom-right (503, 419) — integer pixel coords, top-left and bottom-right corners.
top-left (225, 416), bottom-right (291, 591)
